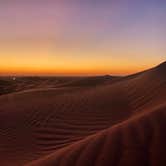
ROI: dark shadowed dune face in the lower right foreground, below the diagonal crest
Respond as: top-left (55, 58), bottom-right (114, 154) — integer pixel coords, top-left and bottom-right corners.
top-left (28, 105), bottom-right (166, 166)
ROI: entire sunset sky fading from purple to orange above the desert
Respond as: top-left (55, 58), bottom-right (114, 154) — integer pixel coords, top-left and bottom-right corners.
top-left (0, 0), bottom-right (166, 75)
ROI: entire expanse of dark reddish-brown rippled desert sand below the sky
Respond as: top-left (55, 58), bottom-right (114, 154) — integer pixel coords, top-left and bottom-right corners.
top-left (0, 62), bottom-right (166, 166)
